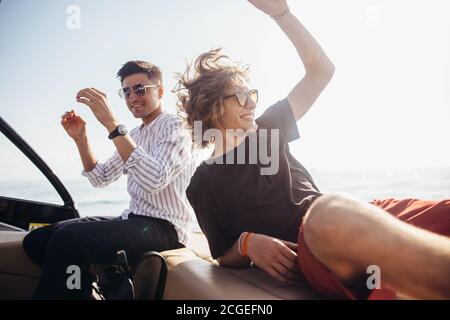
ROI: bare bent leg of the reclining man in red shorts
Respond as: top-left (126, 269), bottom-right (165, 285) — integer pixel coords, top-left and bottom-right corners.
top-left (303, 195), bottom-right (450, 299)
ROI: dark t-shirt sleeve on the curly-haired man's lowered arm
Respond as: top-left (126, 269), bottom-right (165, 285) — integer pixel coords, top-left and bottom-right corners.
top-left (186, 172), bottom-right (235, 259)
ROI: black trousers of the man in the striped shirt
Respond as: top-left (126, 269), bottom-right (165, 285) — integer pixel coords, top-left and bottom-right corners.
top-left (23, 213), bottom-right (182, 299)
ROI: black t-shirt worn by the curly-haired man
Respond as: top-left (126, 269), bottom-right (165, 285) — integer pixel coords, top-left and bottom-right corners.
top-left (186, 99), bottom-right (321, 258)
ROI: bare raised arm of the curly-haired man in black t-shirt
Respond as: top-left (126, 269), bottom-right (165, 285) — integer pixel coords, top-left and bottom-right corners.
top-left (248, 0), bottom-right (334, 121)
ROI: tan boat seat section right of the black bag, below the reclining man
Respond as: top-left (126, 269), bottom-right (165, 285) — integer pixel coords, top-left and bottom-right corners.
top-left (161, 232), bottom-right (320, 300)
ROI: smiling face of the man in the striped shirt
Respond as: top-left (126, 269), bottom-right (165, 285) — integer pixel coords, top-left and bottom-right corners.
top-left (122, 73), bottom-right (164, 124)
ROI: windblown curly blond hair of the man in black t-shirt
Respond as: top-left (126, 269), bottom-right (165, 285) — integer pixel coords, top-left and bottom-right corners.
top-left (173, 48), bottom-right (249, 147)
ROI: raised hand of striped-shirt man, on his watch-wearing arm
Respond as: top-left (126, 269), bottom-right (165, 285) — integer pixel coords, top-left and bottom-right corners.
top-left (77, 88), bottom-right (118, 132)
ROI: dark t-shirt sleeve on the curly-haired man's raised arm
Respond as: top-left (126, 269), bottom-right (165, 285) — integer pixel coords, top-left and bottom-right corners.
top-left (256, 98), bottom-right (300, 142)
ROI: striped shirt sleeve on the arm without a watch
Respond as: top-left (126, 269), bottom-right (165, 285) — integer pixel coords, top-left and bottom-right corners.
top-left (81, 151), bottom-right (124, 188)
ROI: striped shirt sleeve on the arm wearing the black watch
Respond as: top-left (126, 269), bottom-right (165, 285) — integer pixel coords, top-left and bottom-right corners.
top-left (124, 121), bottom-right (192, 193)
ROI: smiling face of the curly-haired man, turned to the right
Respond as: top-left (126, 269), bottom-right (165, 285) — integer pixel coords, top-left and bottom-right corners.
top-left (218, 84), bottom-right (257, 131)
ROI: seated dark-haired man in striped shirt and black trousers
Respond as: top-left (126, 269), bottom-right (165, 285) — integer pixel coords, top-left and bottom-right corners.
top-left (23, 61), bottom-right (195, 299)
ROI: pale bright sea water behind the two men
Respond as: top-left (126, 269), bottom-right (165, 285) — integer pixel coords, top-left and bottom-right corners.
top-left (0, 167), bottom-right (450, 221)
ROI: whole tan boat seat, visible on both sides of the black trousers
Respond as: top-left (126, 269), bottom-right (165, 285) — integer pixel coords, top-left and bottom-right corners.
top-left (0, 231), bottom-right (320, 300)
